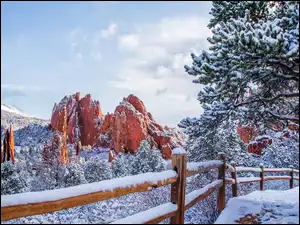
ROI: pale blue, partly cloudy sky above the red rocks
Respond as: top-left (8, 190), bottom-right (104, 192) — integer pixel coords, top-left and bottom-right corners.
top-left (1, 1), bottom-right (211, 126)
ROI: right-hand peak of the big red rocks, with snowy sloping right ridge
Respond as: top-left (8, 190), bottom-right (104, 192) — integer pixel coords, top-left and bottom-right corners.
top-left (101, 95), bottom-right (181, 159)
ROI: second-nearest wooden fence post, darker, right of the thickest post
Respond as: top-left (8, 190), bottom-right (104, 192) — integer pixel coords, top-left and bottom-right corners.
top-left (218, 152), bottom-right (226, 215)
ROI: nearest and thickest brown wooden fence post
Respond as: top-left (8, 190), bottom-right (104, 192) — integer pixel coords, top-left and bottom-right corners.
top-left (170, 153), bottom-right (186, 224)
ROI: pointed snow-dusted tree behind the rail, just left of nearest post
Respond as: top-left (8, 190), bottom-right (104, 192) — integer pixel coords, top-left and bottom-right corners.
top-left (129, 140), bottom-right (166, 175)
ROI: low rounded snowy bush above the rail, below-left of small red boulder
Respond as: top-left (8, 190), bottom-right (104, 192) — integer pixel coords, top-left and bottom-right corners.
top-left (84, 156), bottom-right (113, 183)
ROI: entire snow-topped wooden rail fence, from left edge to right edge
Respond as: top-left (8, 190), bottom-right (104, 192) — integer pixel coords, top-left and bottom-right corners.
top-left (1, 153), bottom-right (299, 224)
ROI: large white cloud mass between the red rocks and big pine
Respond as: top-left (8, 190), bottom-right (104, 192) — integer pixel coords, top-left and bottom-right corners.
top-left (109, 16), bottom-right (210, 126)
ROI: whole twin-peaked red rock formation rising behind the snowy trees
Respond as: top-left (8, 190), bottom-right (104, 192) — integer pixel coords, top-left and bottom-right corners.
top-left (47, 93), bottom-right (182, 161)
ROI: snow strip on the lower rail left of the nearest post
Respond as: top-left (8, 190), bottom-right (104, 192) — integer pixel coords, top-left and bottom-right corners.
top-left (111, 202), bottom-right (177, 224)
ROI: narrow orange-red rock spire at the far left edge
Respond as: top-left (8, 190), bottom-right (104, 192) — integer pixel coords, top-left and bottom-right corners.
top-left (1, 125), bottom-right (15, 164)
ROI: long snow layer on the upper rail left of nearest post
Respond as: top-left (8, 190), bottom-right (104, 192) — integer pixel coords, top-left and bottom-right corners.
top-left (1, 170), bottom-right (177, 207)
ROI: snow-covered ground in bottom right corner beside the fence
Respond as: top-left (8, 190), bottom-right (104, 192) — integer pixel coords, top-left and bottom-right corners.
top-left (215, 187), bottom-right (299, 224)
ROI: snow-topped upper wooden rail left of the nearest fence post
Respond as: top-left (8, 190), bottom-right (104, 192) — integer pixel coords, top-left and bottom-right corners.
top-left (1, 170), bottom-right (177, 221)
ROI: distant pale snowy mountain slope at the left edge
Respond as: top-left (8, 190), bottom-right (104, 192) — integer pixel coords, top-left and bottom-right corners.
top-left (1, 104), bottom-right (50, 130)
